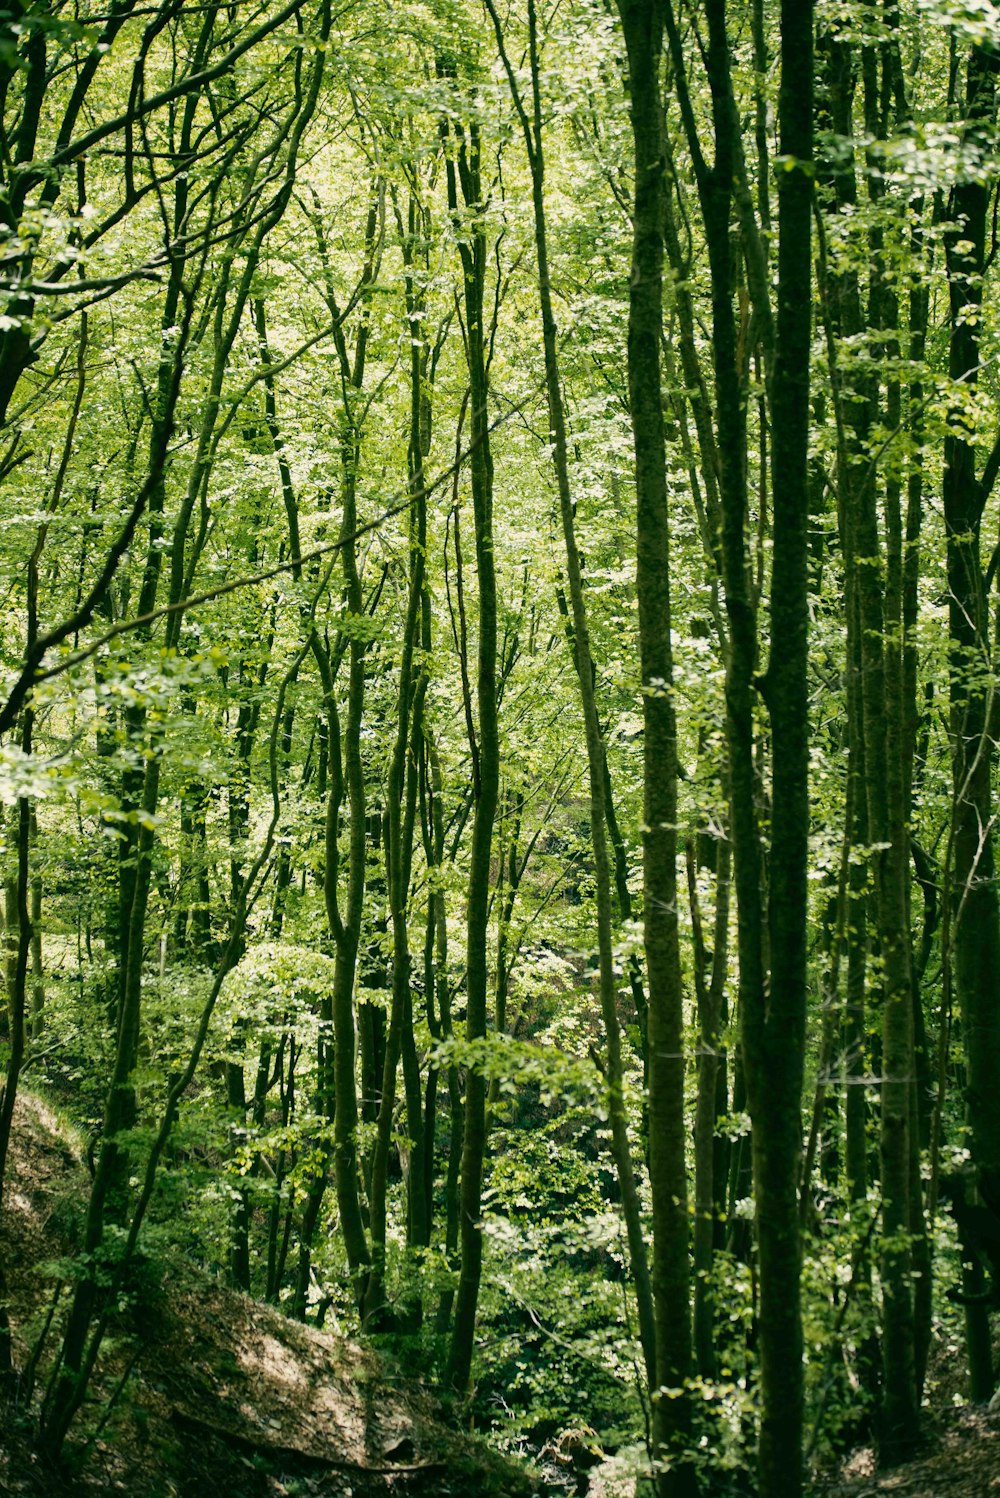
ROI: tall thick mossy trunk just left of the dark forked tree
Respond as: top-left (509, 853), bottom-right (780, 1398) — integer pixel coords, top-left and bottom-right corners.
top-left (618, 0), bottom-right (696, 1498)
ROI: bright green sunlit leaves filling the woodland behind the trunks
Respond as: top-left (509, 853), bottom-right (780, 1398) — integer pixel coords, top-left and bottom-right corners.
top-left (0, 0), bottom-right (1000, 1491)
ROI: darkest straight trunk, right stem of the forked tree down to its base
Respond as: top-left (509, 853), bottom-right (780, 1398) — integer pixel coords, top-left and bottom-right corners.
top-left (748, 0), bottom-right (813, 1480)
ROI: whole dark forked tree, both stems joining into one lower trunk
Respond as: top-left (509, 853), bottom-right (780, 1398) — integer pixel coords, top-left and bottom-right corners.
top-left (666, 4), bottom-right (813, 1494)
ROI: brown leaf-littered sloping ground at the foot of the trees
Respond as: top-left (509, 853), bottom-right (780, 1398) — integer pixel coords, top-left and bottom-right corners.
top-left (0, 1098), bottom-right (1000, 1498)
